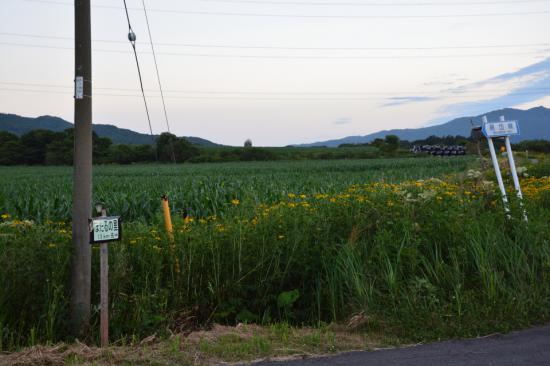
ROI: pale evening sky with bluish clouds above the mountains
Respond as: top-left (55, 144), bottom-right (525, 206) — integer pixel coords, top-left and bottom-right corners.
top-left (0, 0), bottom-right (550, 146)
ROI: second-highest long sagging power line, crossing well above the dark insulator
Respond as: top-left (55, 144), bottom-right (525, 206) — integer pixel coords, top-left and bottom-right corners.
top-left (19, 0), bottom-right (550, 19)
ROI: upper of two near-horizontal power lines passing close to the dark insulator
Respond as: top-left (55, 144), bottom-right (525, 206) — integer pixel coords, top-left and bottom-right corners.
top-left (0, 32), bottom-right (550, 51)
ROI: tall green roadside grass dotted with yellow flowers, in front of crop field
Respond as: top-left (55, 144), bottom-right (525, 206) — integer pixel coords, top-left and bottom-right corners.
top-left (0, 159), bottom-right (550, 349)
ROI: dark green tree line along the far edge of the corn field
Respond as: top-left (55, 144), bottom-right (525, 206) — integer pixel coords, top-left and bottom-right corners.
top-left (0, 129), bottom-right (550, 165)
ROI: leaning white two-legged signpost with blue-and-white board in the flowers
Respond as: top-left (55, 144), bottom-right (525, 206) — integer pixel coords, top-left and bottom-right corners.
top-left (482, 116), bottom-right (527, 221)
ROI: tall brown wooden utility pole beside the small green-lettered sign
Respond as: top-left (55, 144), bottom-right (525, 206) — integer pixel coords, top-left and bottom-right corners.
top-left (71, 0), bottom-right (92, 339)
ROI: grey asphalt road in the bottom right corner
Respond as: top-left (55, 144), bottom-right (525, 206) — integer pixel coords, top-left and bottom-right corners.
top-left (256, 325), bottom-right (550, 366)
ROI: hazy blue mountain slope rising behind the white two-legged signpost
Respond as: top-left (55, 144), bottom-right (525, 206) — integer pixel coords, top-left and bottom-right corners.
top-left (300, 107), bottom-right (550, 147)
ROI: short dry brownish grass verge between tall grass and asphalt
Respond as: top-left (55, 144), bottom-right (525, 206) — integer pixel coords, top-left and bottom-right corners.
top-left (0, 324), bottom-right (400, 365)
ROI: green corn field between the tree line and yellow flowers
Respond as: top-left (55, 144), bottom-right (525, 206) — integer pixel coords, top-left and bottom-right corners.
top-left (0, 158), bottom-right (471, 222)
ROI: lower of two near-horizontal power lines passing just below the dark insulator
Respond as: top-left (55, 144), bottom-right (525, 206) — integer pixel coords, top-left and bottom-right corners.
top-left (0, 42), bottom-right (547, 60)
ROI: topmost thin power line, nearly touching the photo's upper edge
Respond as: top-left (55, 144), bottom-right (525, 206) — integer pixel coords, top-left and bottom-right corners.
top-left (202, 0), bottom-right (549, 7)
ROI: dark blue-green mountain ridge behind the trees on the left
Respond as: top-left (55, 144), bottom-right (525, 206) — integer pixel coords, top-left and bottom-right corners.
top-left (0, 113), bottom-right (220, 146)
